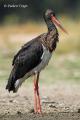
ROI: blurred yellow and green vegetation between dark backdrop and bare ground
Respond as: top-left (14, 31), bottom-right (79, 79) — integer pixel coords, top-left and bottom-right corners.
top-left (0, 16), bottom-right (80, 84)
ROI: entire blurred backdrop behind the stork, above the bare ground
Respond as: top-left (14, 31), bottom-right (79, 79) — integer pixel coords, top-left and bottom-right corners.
top-left (0, 0), bottom-right (80, 84)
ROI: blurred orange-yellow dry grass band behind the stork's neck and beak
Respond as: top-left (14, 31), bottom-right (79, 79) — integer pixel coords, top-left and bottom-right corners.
top-left (0, 16), bottom-right (80, 53)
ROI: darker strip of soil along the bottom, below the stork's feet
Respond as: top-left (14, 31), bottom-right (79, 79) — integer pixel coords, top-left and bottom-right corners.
top-left (0, 113), bottom-right (80, 120)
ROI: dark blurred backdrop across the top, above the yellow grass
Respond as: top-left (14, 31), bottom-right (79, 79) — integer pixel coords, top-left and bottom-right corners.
top-left (0, 0), bottom-right (80, 23)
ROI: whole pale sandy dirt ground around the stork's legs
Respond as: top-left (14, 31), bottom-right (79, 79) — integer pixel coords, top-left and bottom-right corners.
top-left (0, 82), bottom-right (80, 120)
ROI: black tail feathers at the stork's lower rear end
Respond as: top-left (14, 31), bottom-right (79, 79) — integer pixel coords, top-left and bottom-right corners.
top-left (6, 69), bottom-right (16, 92)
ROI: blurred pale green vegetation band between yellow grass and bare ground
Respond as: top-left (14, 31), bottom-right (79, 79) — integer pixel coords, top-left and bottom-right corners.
top-left (0, 50), bottom-right (80, 85)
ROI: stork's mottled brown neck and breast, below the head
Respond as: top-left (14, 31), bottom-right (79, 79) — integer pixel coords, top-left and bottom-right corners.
top-left (42, 21), bottom-right (58, 52)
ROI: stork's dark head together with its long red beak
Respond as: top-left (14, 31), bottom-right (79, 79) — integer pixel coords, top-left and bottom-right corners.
top-left (44, 9), bottom-right (67, 33)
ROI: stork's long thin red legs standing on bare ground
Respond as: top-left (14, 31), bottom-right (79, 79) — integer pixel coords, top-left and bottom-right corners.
top-left (34, 73), bottom-right (41, 113)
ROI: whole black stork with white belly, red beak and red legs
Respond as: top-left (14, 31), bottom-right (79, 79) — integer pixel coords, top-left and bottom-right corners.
top-left (6, 9), bottom-right (67, 113)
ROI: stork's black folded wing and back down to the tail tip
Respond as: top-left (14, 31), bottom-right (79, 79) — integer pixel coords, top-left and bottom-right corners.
top-left (6, 39), bottom-right (43, 92)
